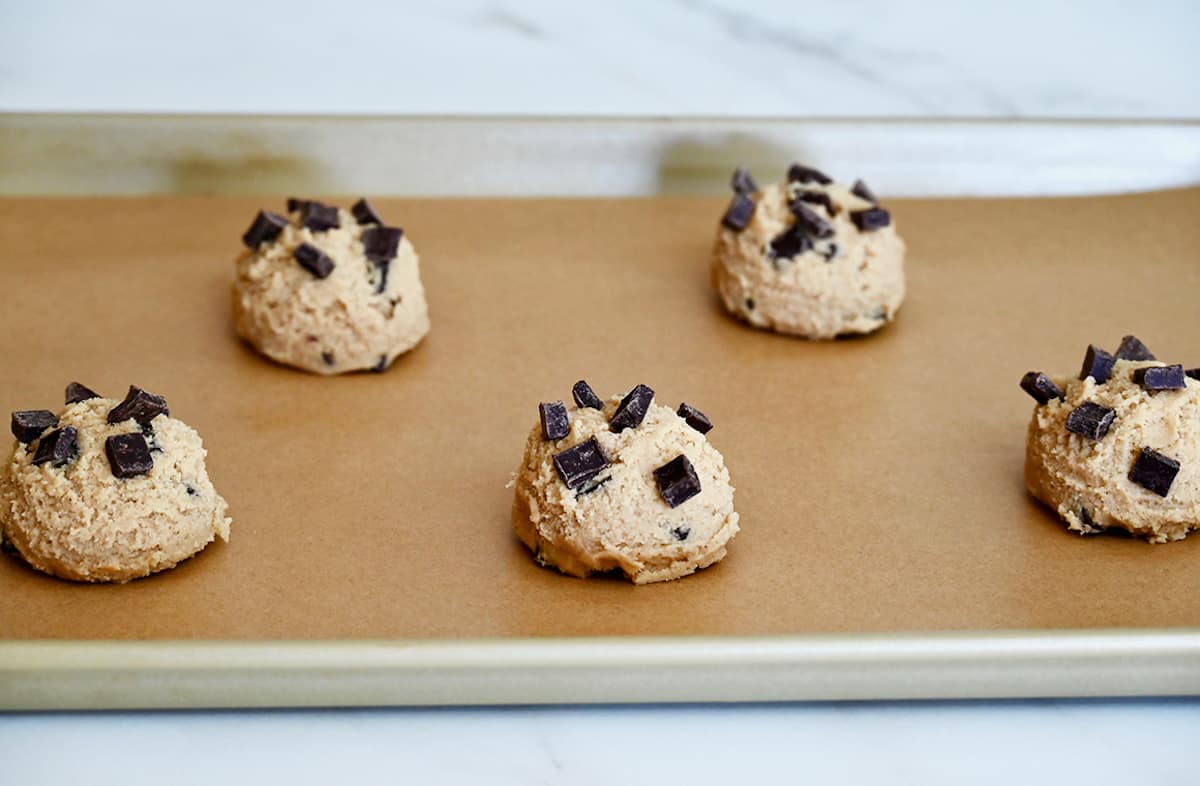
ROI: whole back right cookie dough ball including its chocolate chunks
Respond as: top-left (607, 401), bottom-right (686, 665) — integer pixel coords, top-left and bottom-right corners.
top-left (712, 164), bottom-right (905, 338)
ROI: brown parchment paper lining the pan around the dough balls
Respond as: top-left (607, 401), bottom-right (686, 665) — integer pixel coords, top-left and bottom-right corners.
top-left (0, 190), bottom-right (1200, 705)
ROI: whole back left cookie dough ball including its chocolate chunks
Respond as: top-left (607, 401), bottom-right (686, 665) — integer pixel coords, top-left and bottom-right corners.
top-left (233, 199), bottom-right (430, 374)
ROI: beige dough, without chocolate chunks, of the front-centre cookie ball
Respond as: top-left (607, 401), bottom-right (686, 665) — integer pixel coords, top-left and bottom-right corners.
top-left (512, 396), bottom-right (738, 584)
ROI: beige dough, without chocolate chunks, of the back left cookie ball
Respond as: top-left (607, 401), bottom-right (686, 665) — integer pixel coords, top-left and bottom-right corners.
top-left (233, 209), bottom-right (430, 374)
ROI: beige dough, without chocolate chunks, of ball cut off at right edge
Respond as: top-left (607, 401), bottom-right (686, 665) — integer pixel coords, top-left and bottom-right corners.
top-left (1025, 360), bottom-right (1200, 544)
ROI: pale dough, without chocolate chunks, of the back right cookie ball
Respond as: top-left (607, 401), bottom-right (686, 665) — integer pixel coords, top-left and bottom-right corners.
top-left (712, 182), bottom-right (905, 338)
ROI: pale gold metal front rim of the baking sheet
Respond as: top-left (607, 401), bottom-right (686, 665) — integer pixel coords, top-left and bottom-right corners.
top-left (0, 628), bottom-right (1200, 710)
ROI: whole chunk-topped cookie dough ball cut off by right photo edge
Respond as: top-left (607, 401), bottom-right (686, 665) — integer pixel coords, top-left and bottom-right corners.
top-left (1021, 336), bottom-right (1200, 544)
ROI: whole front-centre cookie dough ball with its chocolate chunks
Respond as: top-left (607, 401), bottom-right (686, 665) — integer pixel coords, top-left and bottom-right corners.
top-left (512, 380), bottom-right (738, 584)
